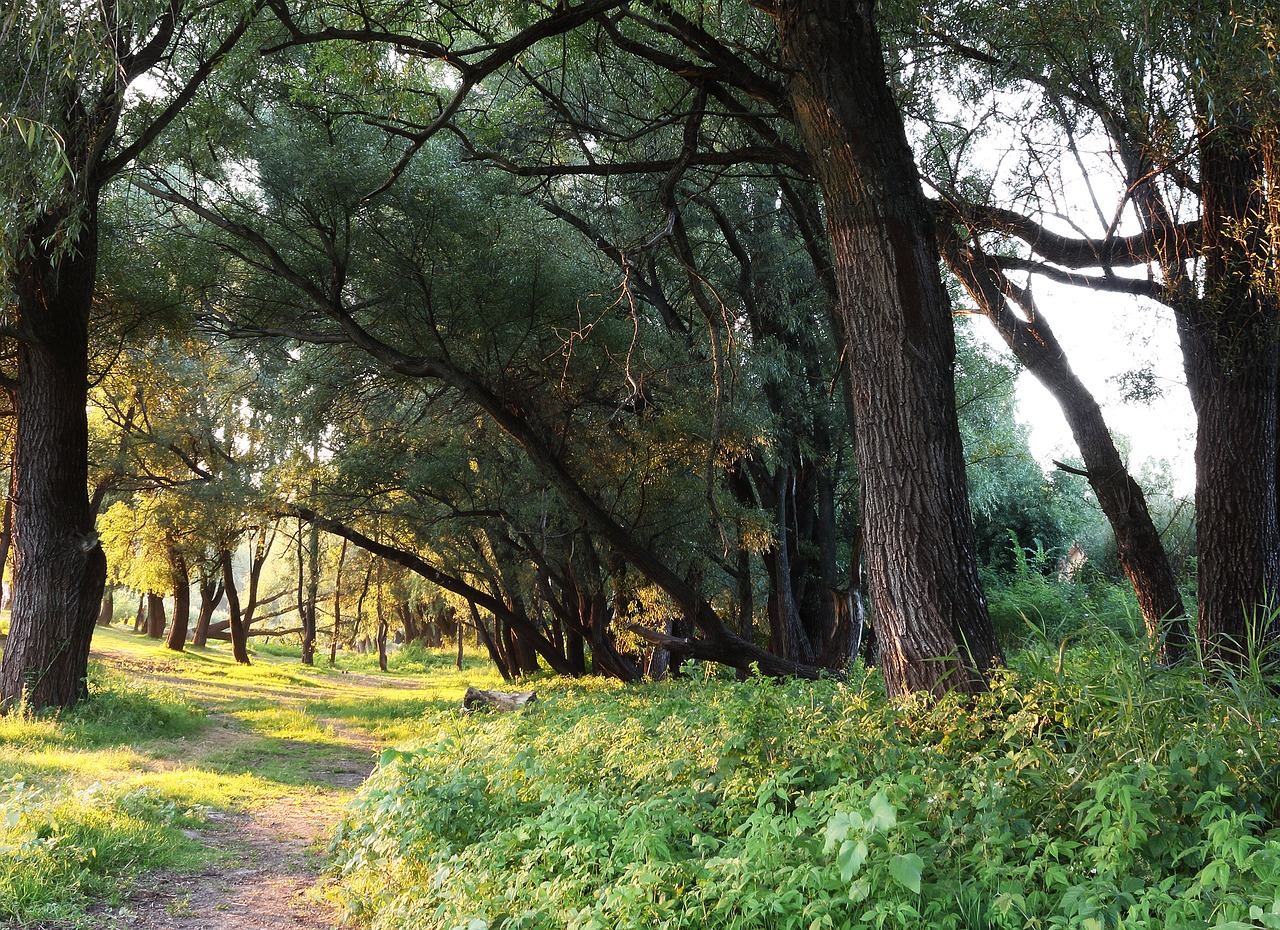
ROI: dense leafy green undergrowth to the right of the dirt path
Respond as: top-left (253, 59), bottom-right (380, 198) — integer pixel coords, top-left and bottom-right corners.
top-left (334, 647), bottom-right (1280, 930)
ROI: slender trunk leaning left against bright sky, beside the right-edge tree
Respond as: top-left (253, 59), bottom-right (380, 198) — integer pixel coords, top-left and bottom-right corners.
top-left (942, 239), bottom-right (1190, 665)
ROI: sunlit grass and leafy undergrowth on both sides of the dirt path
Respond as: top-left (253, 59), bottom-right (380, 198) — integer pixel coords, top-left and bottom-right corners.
top-left (17, 603), bottom-right (1280, 930)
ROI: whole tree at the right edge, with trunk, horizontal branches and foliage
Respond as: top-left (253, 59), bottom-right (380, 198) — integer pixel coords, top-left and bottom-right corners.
top-left (922, 1), bottom-right (1280, 664)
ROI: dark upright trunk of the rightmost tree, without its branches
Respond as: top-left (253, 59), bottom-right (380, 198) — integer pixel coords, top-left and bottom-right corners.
top-left (1180, 112), bottom-right (1280, 665)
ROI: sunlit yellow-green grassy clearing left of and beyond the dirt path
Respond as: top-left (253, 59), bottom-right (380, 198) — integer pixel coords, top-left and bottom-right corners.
top-left (0, 621), bottom-right (493, 927)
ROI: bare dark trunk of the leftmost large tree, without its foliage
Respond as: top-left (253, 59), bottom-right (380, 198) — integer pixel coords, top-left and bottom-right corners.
top-left (0, 209), bottom-right (106, 709)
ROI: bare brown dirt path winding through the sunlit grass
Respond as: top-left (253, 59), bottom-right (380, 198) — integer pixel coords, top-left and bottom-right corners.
top-left (80, 652), bottom-right (399, 930)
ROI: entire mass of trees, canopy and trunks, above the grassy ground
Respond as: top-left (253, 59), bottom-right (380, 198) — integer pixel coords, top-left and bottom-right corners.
top-left (0, 0), bottom-right (1280, 705)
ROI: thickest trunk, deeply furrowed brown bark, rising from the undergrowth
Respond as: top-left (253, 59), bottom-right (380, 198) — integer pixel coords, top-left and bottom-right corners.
top-left (772, 0), bottom-right (1004, 697)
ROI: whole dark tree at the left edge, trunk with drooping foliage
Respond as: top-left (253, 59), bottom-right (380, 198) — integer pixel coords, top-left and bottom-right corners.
top-left (0, 0), bottom-right (260, 707)
